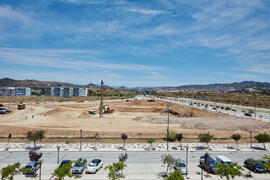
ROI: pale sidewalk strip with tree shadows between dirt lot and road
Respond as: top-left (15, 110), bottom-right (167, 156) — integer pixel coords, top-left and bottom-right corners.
top-left (0, 143), bottom-right (270, 152)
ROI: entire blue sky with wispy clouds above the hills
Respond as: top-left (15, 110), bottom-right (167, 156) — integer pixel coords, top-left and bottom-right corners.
top-left (0, 0), bottom-right (270, 87)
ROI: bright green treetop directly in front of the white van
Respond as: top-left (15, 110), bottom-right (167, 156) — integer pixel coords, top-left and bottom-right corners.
top-left (216, 163), bottom-right (243, 180)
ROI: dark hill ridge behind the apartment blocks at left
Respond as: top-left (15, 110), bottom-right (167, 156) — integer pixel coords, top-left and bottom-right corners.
top-left (0, 78), bottom-right (100, 88)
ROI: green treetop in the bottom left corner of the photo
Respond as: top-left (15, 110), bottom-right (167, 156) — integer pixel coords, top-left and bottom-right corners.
top-left (1, 162), bottom-right (23, 180)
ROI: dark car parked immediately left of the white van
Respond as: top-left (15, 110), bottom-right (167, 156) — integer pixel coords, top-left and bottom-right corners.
top-left (200, 153), bottom-right (217, 174)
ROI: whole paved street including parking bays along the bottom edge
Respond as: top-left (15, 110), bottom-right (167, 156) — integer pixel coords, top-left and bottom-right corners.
top-left (0, 151), bottom-right (270, 180)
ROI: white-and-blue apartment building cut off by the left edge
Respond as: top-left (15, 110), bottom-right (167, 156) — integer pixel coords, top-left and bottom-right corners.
top-left (0, 87), bottom-right (31, 96)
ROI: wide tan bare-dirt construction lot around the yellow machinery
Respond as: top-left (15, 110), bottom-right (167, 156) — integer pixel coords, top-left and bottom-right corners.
top-left (0, 100), bottom-right (270, 138)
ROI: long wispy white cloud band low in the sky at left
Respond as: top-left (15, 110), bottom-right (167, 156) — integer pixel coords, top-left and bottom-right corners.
top-left (0, 48), bottom-right (161, 71)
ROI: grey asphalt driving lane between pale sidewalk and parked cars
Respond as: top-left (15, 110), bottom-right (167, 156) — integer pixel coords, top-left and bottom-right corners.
top-left (0, 151), bottom-right (270, 164)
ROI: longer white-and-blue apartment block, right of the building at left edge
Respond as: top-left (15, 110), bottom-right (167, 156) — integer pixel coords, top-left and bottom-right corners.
top-left (45, 87), bottom-right (88, 98)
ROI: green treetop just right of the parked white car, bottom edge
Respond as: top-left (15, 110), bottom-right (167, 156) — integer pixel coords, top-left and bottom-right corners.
top-left (105, 161), bottom-right (126, 180)
